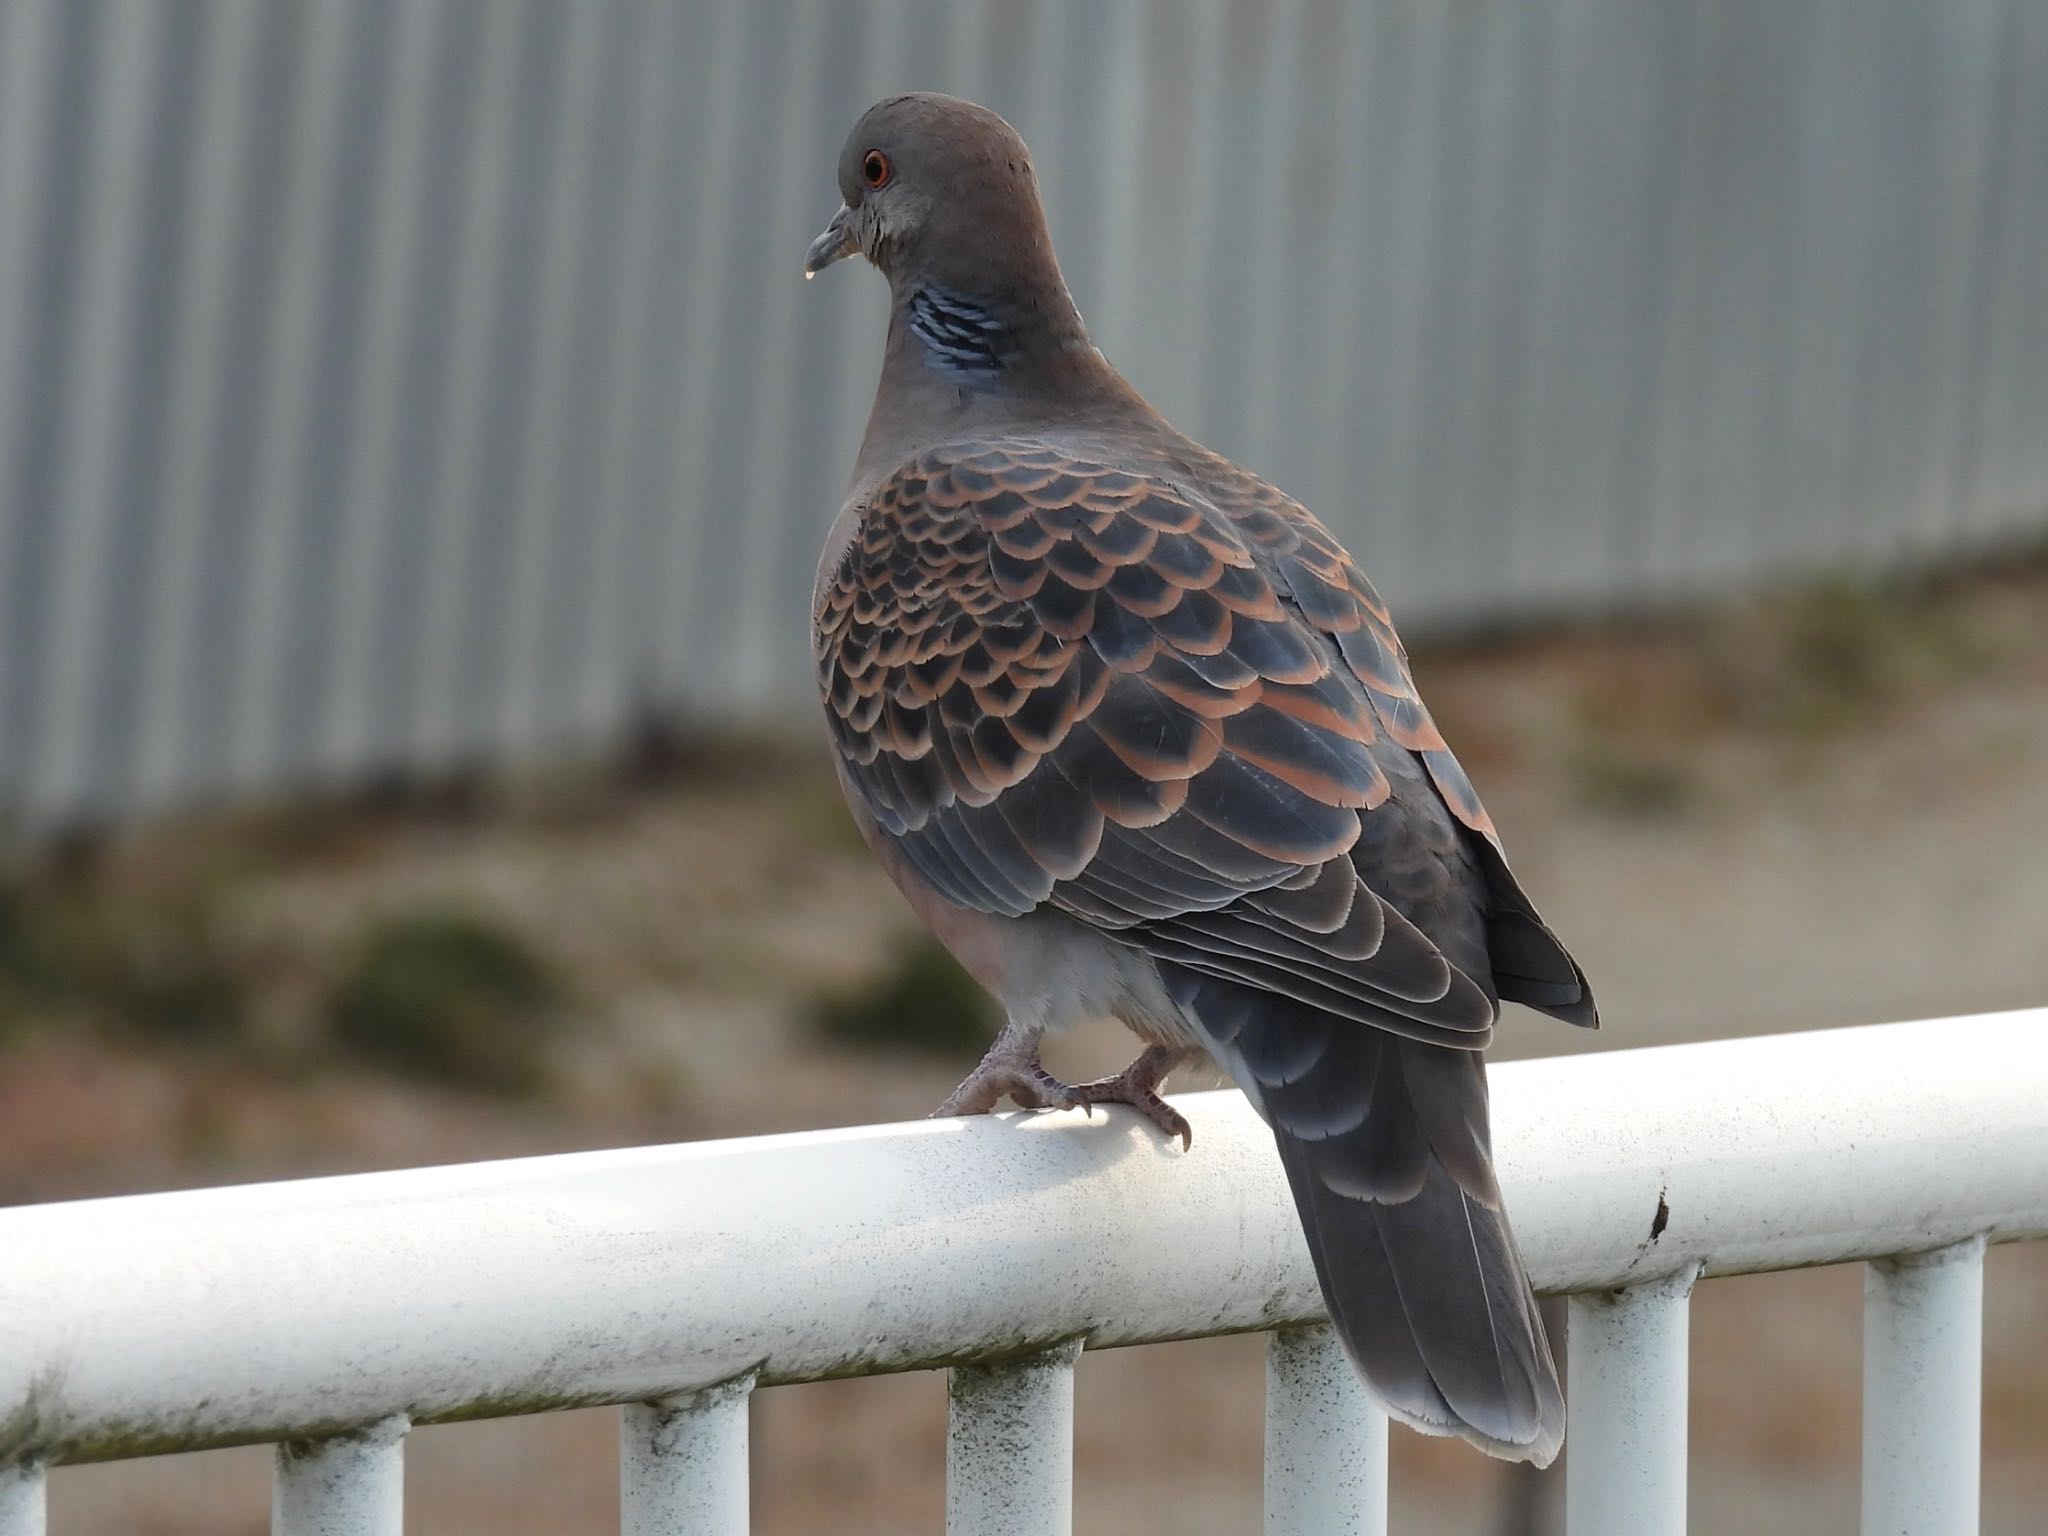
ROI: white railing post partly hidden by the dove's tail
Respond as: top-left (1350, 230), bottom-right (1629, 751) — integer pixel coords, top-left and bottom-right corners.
top-left (1266, 1327), bottom-right (1386, 1536)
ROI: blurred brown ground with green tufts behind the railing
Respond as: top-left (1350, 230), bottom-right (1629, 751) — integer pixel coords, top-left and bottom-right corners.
top-left (16, 561), bottom-right (2048, 1536)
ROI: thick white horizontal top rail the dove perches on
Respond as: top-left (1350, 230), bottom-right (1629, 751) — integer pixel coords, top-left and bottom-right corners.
top-left (0, 1010), bottom-right (2048, 1462)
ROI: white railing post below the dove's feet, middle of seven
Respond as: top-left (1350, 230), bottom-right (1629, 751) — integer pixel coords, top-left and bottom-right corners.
top-left (946, 1339), bottom-right (1081, 1536)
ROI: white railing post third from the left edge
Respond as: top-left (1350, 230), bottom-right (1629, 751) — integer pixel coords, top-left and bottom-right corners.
top-left (618, 1372), bottom-right (754, 1536)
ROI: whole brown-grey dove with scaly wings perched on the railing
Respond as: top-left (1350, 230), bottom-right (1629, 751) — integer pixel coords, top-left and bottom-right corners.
top-left (805, 94), bottom-right (1597, 1464)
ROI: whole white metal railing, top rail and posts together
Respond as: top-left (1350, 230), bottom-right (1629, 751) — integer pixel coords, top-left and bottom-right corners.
top-left (0, 1010), bottom-right (2048, 1536)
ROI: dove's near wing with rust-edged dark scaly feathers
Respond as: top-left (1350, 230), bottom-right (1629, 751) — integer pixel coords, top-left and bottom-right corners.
top-left (815, 440), bottom-right (1523, 1049)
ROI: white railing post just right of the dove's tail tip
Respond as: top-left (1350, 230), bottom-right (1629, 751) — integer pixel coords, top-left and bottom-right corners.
top-left (1565, 1268), bottom-right (1698, 1536)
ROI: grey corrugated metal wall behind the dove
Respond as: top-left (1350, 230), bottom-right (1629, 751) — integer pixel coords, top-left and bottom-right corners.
top-left (0, 0), bottom-right (2048, 835)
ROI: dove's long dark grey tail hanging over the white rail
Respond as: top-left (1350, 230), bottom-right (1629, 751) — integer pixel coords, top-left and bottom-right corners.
top-left (1196, 981), bottom-right (1565, 1466)
